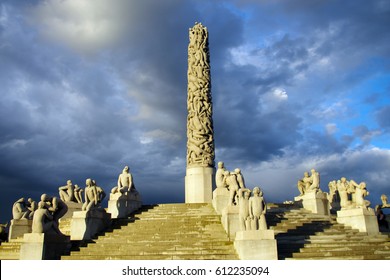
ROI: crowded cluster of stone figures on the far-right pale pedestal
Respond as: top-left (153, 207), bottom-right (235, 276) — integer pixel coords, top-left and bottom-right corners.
top-left (328, 177), bottom-right (370, 209)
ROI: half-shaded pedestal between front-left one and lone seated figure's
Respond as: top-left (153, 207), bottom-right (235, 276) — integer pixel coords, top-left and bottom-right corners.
top-left (70, 208), bottom-right (111, 240)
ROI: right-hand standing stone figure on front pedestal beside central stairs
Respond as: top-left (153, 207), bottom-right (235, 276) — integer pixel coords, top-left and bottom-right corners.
top-left (249, 187), bottom-right (267, 230)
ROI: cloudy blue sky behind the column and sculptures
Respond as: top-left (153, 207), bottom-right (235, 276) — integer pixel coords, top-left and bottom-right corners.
top-left (0, 0), bottom-right (390, 222)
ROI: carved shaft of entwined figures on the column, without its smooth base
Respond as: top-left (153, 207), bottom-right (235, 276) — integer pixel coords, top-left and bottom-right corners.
top-left (187, 23), bottom-right (215, 167)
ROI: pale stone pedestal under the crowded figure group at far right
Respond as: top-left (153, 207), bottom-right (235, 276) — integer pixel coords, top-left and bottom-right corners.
top-left (337, 208), bottom-right (379, 234)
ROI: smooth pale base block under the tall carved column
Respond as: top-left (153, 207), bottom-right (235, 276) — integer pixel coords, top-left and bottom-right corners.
top-left (185, 167), bottom-right (215, 203)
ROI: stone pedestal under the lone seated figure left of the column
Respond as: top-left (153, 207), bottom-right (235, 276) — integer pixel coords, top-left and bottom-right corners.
top-left (107, 192), bottom-right (142, 219)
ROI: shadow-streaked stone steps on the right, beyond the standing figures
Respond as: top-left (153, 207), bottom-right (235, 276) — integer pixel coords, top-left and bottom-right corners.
top-left (267, 204), bottom-right (390, 260)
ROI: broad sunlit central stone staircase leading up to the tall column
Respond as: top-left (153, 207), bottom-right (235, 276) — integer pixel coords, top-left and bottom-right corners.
top-left (62, 203), bottom-right (238, 260)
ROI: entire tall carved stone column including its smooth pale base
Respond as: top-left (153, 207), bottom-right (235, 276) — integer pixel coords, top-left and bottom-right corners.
top-left (185, 23), bottom-right (215, 203)
